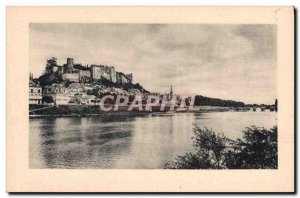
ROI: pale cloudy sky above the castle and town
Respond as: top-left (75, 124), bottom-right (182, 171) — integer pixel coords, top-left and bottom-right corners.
top-left (29, 23), bottom-right (277, 104)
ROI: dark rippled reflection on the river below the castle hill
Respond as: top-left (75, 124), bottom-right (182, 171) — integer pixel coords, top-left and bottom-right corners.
top-left (40, 116), bottom-right (135, 168)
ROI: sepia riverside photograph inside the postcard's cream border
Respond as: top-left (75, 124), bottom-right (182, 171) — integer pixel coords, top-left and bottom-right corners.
top-left (28, 23), bottom-right (278, 169)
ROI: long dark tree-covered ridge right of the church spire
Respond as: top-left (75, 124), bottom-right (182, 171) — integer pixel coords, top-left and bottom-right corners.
top-left (194, 95), bottom-right (245, 107)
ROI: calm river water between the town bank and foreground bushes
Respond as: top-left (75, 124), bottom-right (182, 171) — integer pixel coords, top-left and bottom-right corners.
top-left (29, 112), bottom-right (277, 169)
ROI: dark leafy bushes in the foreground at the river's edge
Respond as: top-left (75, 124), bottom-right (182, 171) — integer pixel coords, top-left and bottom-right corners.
top-left (165, 125), bottom-right (278, 169)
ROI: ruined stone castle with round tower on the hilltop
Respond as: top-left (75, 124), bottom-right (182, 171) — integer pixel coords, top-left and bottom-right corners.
top-left (45, 58), bottom-right (133, 84)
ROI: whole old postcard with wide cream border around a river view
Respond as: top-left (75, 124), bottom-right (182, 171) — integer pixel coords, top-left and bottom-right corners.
top-left (7, 7), bottom-right (294, 192)
